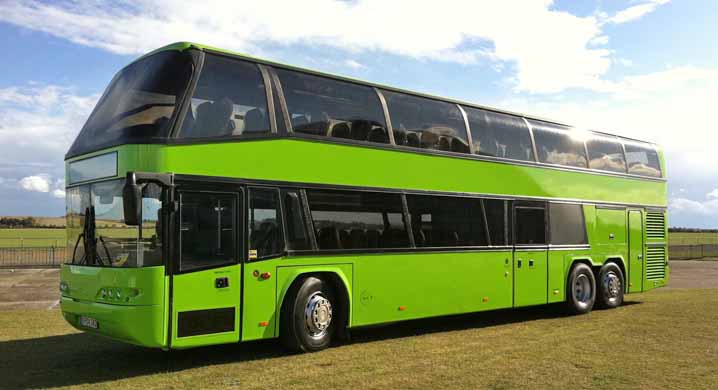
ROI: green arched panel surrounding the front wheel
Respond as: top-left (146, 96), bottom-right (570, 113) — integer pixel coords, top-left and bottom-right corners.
top-left (275, 264), bottom-right (353, 336)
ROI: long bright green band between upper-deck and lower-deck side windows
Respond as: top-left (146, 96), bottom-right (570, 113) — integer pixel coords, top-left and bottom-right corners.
top-left (149, 139), bottom-right (667, 207)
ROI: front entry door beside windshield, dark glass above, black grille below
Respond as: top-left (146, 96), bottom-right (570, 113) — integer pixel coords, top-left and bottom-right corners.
top-left (170, 188), bottom-right (243, 348)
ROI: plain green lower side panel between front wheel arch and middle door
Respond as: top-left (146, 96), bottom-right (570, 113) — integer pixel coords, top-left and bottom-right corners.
top-left (353, 250), bottom-right (516, 326)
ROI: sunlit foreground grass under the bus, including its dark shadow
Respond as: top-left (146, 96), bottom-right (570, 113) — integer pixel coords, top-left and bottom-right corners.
top-left (0, 289), bottom-right (718, 389)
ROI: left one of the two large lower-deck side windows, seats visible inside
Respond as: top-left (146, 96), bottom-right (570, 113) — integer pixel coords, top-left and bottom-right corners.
top-left (307, 190), bottom-right (409, 249)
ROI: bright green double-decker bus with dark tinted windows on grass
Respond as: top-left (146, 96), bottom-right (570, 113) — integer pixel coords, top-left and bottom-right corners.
top-left (60, 43), bottom-right (668, 351)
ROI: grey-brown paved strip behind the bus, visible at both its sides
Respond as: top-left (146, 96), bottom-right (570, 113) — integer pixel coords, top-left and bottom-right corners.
top-left (0, 260), bottom-right (718, 310)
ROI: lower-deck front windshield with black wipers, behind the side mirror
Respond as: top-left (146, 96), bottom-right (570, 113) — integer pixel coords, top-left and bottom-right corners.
top-left (67, 180), bottom-right (162, 267)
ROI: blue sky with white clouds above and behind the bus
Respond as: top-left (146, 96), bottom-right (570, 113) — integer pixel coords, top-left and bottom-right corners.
top-left (0, 0), bottom-right (718, 228)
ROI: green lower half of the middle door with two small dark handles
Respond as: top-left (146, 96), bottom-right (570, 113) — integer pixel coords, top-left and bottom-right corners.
top-left (514, 249), bottom-right (548, 307)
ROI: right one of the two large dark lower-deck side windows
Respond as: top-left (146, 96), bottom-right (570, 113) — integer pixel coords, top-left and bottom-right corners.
top-left (406, 195), bottom-right (488, 247)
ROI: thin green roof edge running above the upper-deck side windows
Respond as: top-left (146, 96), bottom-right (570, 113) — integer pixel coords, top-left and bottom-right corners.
top-left (127, 41), bottom-right (658, 148)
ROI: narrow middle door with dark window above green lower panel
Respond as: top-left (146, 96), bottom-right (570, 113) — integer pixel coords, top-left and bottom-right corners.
top-left (513, 202), bottom-right (548, 307)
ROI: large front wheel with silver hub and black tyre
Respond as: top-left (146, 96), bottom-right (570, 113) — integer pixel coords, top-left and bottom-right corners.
top-left (280, 276), bottom-right (339, 352)
